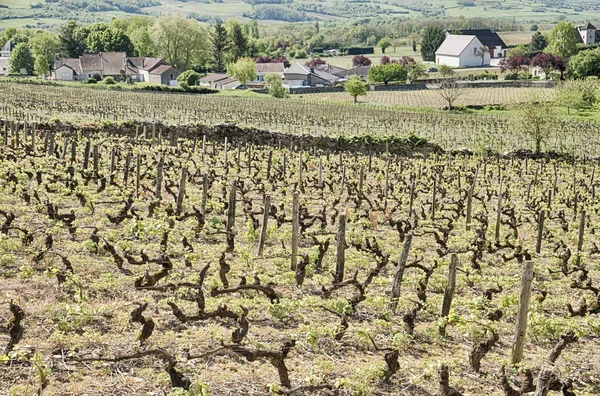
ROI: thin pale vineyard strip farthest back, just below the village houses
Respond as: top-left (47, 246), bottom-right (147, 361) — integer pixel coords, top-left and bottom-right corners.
top-left (300, 88), bottom-right (554, 108)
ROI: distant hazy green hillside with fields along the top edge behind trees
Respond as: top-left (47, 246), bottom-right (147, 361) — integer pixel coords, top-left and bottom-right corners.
top-left (0, 0), bottom-right (600, 29)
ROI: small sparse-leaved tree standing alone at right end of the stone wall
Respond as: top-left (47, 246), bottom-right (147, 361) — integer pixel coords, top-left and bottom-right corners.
top-left (515, 97), bottom-right (557, 154)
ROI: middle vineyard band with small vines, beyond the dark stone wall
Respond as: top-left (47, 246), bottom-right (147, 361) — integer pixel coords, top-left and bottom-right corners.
top-left (0, 82), bottom-right (600, 157)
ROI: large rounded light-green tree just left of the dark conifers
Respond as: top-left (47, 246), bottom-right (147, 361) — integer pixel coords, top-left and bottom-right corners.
top-left (153, 15), bottom-right (207, 70)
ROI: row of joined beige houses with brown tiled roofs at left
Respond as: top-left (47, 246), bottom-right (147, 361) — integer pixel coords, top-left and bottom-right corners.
top-left (53, 52), bottom-right (179, 86)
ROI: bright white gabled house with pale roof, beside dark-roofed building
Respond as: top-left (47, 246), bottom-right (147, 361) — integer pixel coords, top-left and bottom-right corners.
top-left (435, 34), bottom-right (491, 67)
